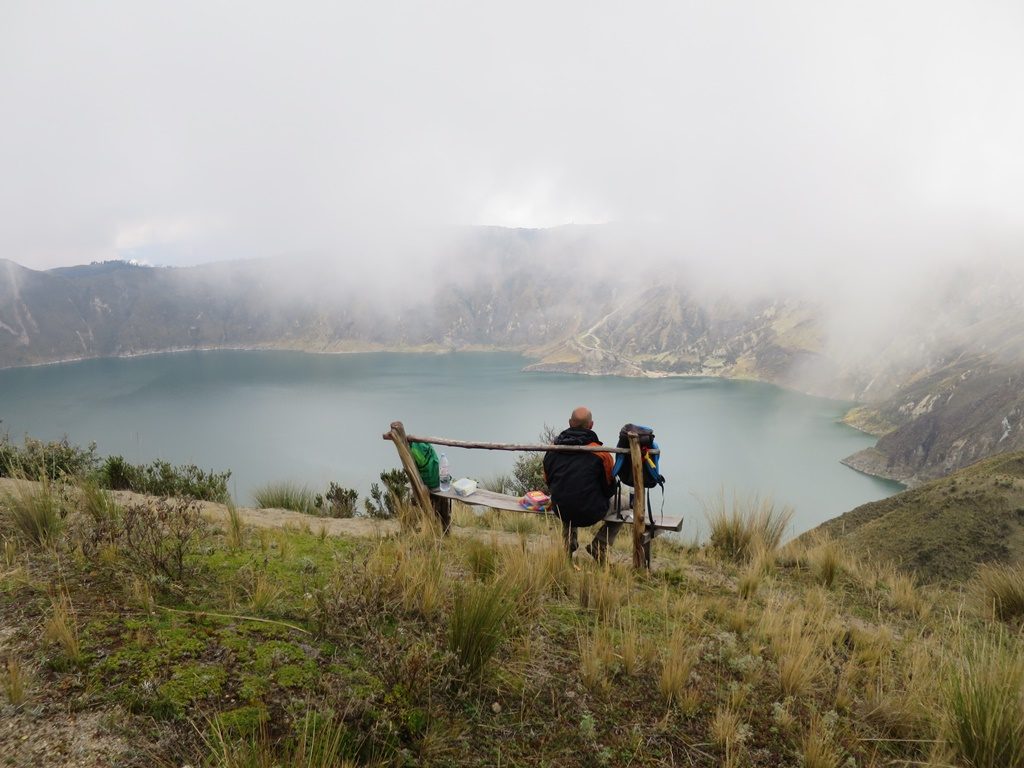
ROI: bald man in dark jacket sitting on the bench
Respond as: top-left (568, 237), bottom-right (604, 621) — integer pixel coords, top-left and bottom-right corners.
top-left (544, 406), bottom-right (623, 562)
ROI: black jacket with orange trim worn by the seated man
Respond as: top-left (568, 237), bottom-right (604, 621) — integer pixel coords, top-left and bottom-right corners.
top-left (544, 428), bottom-right (615, 525)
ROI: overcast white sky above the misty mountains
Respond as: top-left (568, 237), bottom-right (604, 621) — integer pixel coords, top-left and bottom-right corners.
top-left (0, 0), bottom-right (1024, 267)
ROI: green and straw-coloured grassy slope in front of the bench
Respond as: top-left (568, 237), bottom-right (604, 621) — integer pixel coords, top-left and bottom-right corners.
top-left (0, 483), bottom-right (1024, 766)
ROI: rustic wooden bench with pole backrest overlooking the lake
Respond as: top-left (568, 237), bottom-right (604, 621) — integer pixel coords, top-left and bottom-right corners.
top-left (383, 421), bottom-right (683, 568)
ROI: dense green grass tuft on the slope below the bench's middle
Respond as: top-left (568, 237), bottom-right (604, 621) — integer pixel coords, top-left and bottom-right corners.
top-left (447, 580), bottom-right (515, 680)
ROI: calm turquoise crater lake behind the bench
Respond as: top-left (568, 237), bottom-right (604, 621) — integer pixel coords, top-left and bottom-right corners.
top-left (0, 351), bottom-right (900, 536)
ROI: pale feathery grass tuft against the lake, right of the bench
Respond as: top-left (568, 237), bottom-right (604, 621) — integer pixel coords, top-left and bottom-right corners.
top-left (702, 493), bottom-right (794, 562)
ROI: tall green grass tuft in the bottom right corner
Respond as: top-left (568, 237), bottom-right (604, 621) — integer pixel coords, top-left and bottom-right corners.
top-left (946, 636), bottom-right (1024, 768)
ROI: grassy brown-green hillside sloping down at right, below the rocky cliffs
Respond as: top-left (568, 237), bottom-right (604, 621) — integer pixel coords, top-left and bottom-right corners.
top-left (817, 453), bottom-right (1024, 582)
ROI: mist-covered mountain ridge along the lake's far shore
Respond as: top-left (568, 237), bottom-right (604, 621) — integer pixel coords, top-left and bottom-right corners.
top-left (0, 227), bottom-right (1024, 485)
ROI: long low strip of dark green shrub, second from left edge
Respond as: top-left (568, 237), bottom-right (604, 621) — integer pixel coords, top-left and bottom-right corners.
top-left (99, 456), bottom-right (231, 502)
